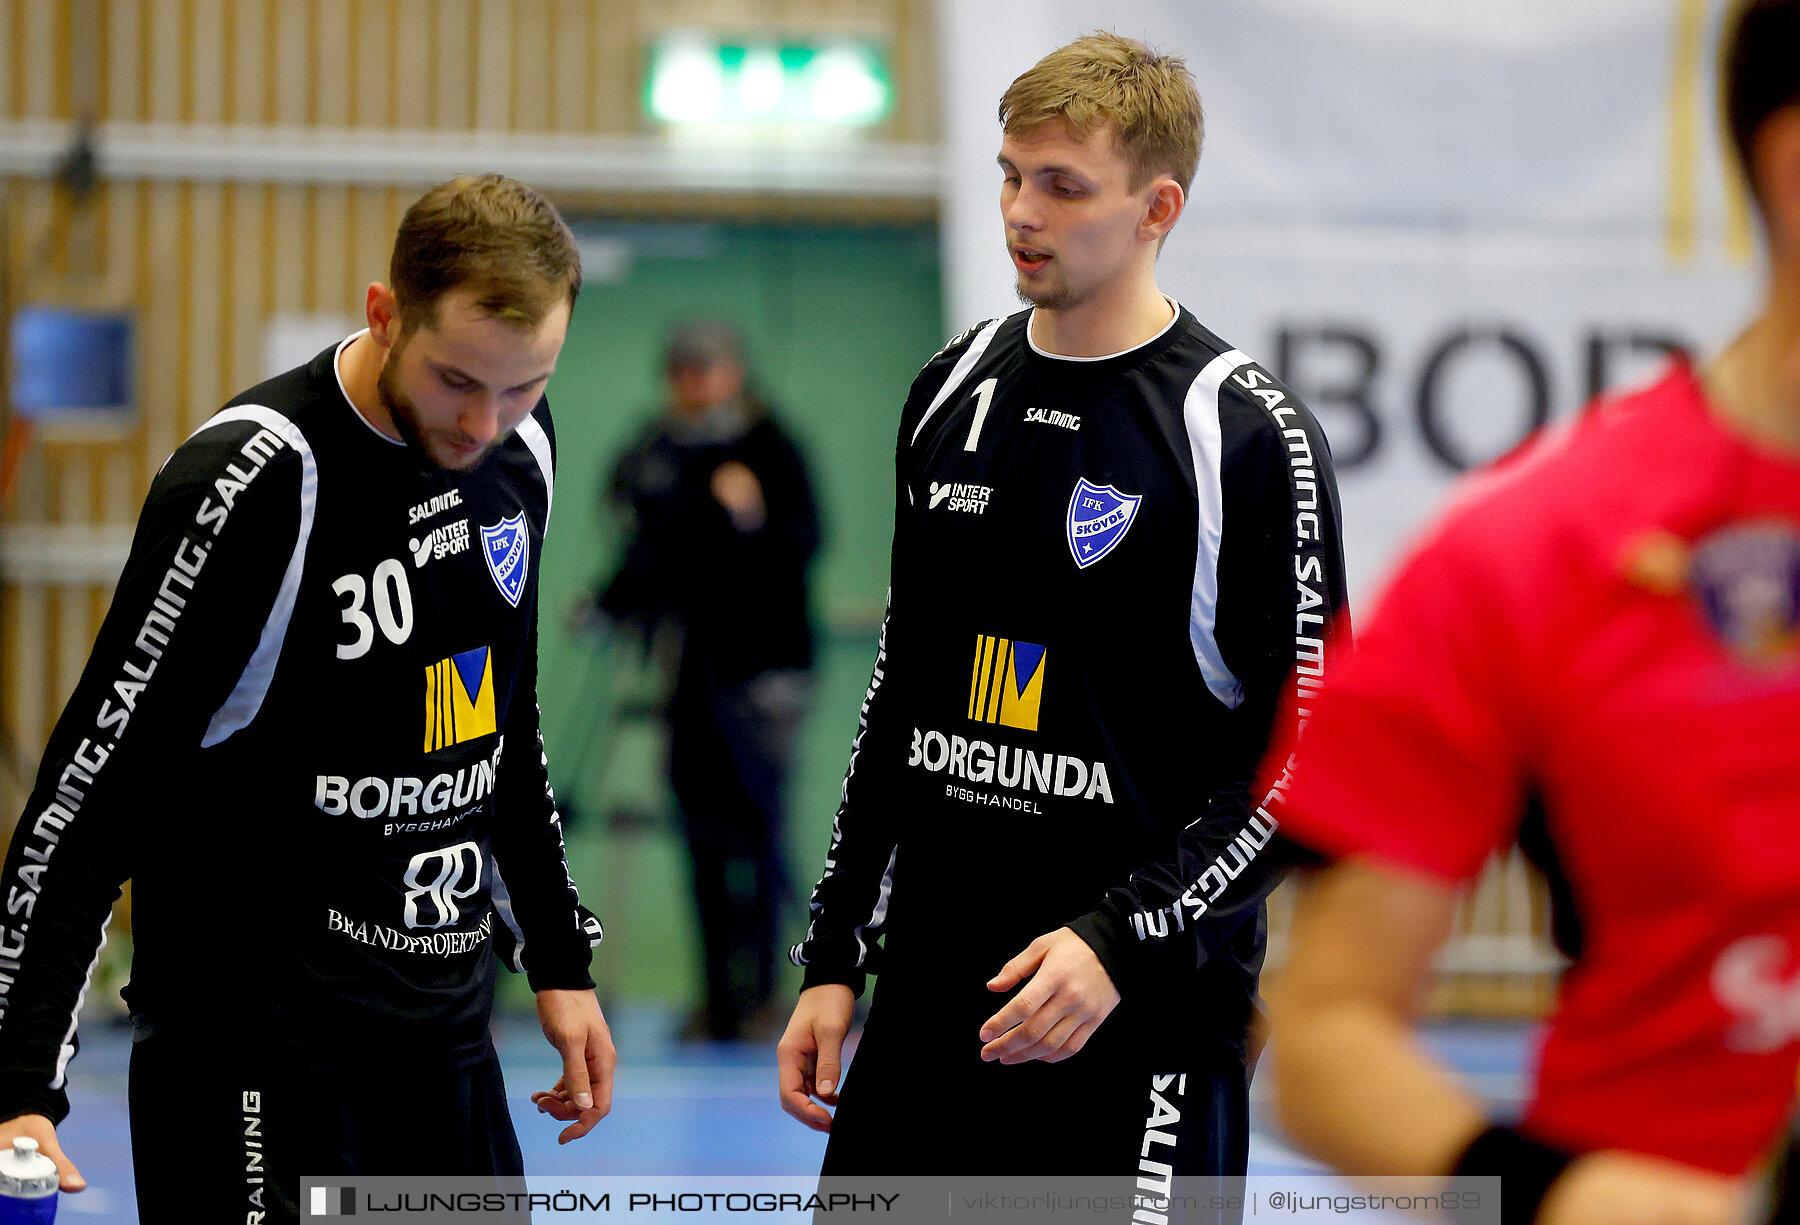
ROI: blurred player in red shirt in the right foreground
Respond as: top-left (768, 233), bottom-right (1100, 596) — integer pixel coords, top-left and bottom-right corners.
top-left (1265, 0), bottom-right (1800, 1225)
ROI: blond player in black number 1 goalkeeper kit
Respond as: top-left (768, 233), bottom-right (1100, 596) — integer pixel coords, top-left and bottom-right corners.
top-left (778, 34), bottom-right (1345, 1220)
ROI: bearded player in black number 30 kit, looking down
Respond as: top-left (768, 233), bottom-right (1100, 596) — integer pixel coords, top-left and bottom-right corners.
top-left (0, 174), bottom-right (614, 1225)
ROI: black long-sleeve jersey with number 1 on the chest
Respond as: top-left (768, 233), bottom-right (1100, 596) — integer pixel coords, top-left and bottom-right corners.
top-left (792, 308), bottom-right (1345, 1052)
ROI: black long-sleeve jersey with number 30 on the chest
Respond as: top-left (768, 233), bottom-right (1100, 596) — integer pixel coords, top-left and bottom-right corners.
top-left (0, 340), bottom-right (599, 1119)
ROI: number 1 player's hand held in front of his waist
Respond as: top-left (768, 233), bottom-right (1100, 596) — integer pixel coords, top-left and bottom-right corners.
top-left (981, 926), bottom-right (1120, 1063)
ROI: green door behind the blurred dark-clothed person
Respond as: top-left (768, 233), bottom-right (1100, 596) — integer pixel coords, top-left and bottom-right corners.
top-left (529, 221), bottom-right (943, 1006)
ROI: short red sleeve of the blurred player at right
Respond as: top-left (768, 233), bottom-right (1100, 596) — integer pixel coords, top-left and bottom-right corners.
top-left (1265, 500), bottom-right (1530, 881)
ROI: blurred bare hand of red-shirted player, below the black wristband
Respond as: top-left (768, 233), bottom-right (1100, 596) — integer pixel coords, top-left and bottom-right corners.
top-left (1533, 1151), bottom-right (1750, 1225)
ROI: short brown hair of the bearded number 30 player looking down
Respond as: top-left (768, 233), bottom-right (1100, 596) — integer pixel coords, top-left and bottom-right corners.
top-left (387, 174), bottom-right (581, 333)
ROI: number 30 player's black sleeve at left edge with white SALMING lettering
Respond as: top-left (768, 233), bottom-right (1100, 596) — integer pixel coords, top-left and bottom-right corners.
top-left (0, 417), bottom-right (306, 1121)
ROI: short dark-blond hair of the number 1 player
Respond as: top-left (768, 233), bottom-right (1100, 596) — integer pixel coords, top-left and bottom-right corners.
top-left (1001, 31), bottom-right (1206, 192)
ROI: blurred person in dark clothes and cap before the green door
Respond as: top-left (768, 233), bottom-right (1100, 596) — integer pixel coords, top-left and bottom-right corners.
top-left (598, 320), bottom-right (819, 1040)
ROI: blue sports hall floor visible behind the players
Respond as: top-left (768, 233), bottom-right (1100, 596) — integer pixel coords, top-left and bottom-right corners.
top-left (58, 1006), bottom-right (1532, 1225)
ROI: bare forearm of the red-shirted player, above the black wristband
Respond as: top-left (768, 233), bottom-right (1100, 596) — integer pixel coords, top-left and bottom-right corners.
top-left (1271, 988), bottom-right (1487, 1176)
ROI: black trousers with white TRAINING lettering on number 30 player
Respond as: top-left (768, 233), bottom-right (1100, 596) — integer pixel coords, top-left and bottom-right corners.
top-left (130, 1025), bottom-right (526, 1225)
